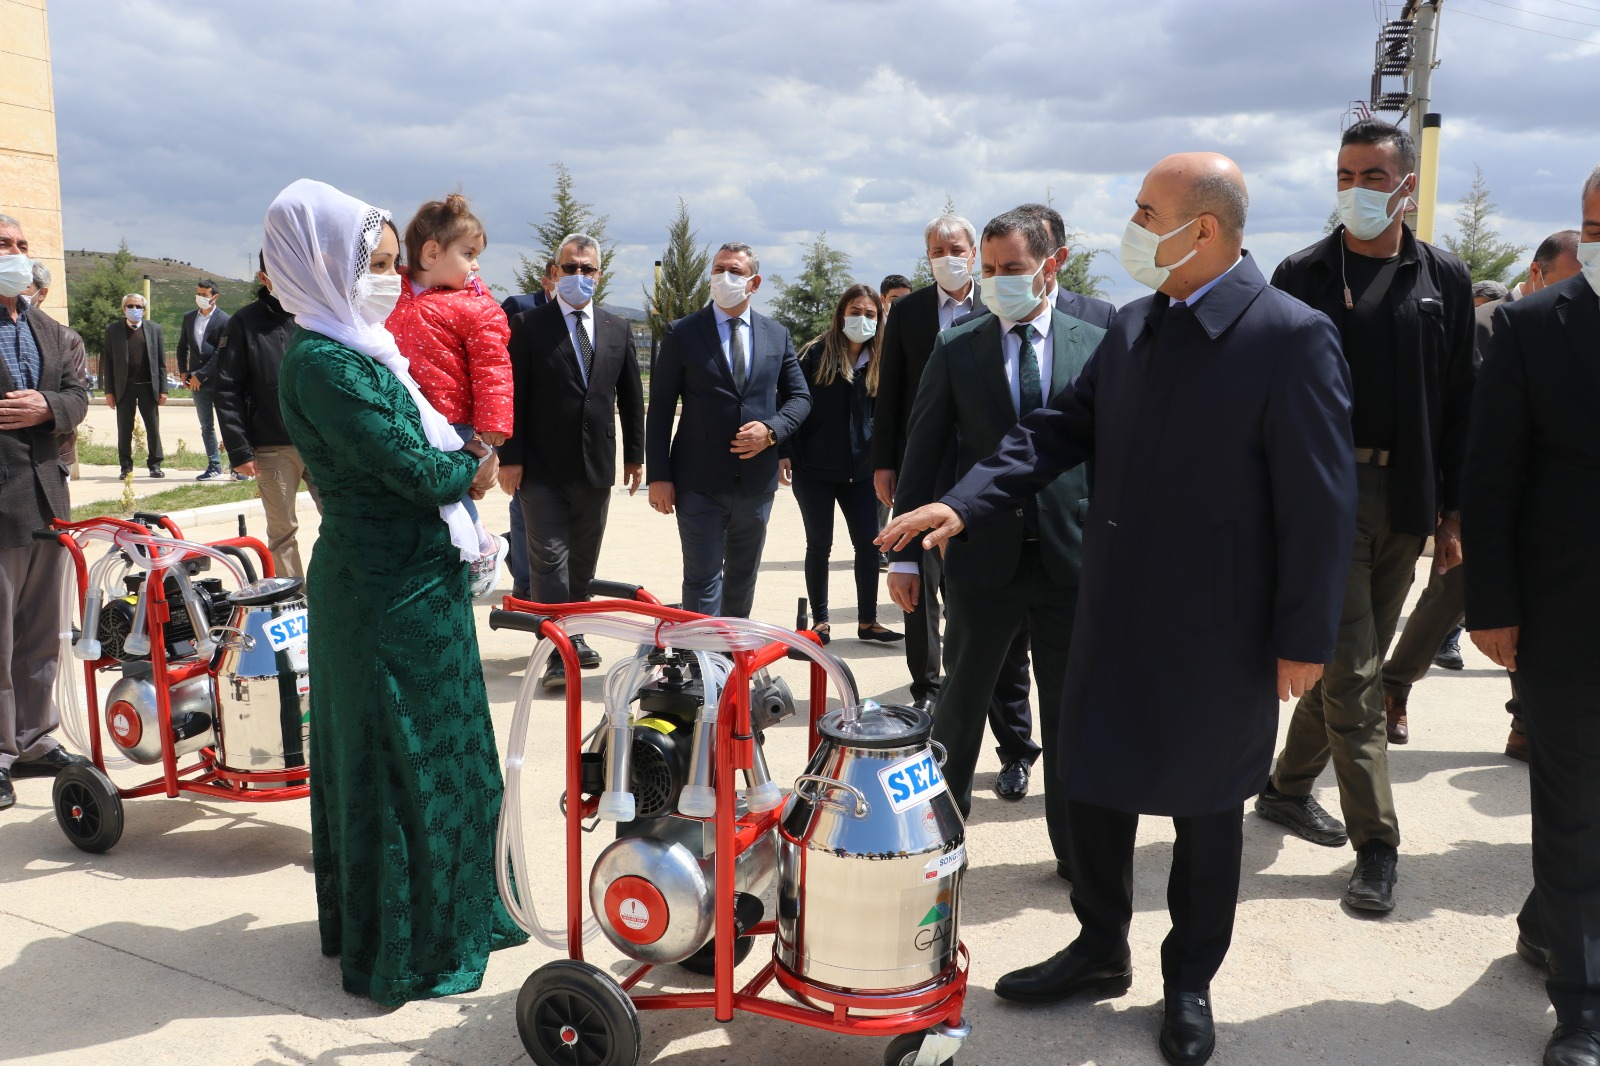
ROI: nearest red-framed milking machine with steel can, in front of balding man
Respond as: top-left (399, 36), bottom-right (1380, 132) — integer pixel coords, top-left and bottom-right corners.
top-left (490, 581), bottom-right (968, 1066)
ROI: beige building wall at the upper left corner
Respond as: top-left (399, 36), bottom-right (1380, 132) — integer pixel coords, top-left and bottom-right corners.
top-left (0, 0), bottom-right (67, 322)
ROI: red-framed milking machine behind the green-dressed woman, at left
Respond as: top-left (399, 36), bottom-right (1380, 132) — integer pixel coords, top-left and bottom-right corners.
top-left (43, 514), bottom-right (310, 852)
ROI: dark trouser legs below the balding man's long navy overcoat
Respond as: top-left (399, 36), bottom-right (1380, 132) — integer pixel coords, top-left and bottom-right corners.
top-left (1067, 800), bottom-right (1245, 992)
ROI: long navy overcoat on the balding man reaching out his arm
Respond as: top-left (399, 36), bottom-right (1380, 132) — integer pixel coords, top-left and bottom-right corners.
top-left (944, 254), bottom-right (1355, 815)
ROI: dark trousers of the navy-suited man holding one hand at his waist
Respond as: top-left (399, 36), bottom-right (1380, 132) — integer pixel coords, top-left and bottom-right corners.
top-left (674, 493), bottom-right (774, 618)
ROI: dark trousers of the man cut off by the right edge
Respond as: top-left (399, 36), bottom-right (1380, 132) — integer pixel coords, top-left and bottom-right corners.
top-left (1512, 669), bottom-right (1600, 1029)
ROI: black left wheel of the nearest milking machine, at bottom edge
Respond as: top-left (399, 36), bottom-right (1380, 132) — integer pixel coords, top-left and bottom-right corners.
top-left (517, 959), bottom-right (642, 1066)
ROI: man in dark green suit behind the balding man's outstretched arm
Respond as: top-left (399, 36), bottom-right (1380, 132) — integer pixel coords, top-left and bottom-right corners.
top-left (890, 210), bottom-right (1106, 872)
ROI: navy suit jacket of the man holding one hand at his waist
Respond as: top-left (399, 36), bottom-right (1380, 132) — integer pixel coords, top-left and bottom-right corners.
top-left (645, 298), bottom-right (806, 495)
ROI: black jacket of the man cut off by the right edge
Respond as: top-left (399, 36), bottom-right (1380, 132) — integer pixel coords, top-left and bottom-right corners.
top-left (1461, 274), bottom-right (1600, 679)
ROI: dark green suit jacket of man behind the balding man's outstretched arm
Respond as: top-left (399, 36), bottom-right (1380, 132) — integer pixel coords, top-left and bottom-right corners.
top-left (894, 311), bottom-right (1106, 586)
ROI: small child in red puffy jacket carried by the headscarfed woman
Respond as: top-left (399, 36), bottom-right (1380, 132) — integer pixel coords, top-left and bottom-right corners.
top-left (386, 194), bottom-right (512, 599)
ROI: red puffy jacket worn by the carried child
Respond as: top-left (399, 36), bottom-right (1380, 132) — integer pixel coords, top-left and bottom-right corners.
top-left (384, 267), bottom-right (514, 437)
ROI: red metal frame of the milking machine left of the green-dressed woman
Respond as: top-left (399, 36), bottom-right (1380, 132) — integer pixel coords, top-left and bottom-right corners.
top-left (51, 515), bottom-right (310, 804)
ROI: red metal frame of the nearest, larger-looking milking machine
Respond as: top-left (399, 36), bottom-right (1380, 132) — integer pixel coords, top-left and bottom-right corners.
top-left (502, 589), bottom-right (968, 1036)
